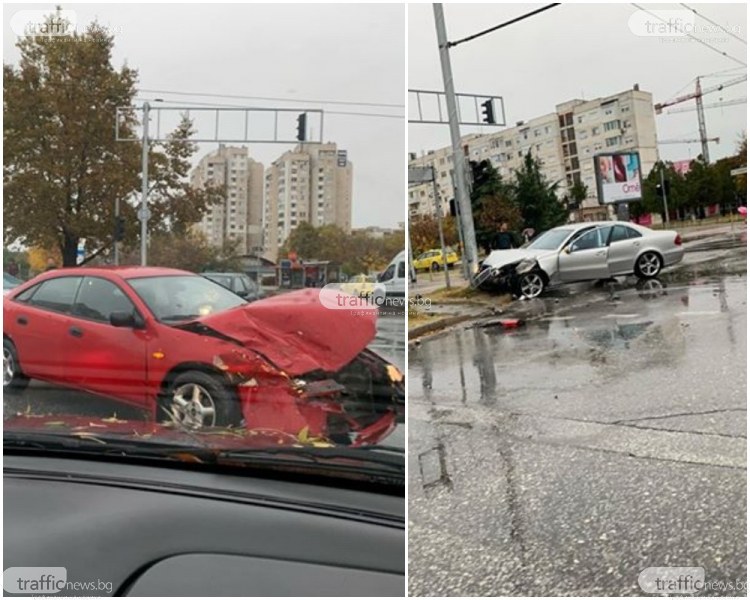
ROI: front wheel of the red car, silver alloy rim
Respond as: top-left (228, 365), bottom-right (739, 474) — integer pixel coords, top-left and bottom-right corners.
top-left (163, 371), bottom-right (242, 429)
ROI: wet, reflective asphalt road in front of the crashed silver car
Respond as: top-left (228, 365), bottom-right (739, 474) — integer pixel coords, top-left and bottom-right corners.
top-left (408, 236), bottom-right (747, 596)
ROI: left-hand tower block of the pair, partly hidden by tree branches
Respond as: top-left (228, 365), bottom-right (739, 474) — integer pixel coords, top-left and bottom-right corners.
top-left (190, 144), bottom-right (263, 254)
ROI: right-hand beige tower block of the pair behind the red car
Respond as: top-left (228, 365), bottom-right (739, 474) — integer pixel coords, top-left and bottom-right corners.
top-left (263, 143), bottom-right (352, 261)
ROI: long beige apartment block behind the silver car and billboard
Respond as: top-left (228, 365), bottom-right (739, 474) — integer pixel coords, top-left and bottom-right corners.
top-left (409, 85), bottom-right (658, 221)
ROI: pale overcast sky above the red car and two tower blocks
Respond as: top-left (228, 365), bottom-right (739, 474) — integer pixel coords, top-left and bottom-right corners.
top-left (3, 3), bottom-right (406, 227)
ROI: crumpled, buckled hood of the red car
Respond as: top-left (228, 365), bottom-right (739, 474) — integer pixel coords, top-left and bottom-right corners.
top-left (198, 289), bottom-right (378, 375)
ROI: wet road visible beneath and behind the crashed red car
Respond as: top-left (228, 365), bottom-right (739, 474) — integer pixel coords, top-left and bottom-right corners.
top-left (3, 314), bottom-right (405, 428)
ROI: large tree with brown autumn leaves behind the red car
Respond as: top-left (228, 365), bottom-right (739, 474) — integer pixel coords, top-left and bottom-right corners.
top-left (3, 10), bottom-right (220, 266)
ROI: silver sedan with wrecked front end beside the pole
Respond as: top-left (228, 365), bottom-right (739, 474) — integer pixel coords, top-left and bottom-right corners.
top-left (475, 221), bottom-right (684, 298)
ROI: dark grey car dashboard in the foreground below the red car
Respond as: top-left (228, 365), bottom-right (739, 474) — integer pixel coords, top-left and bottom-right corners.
top-left (4, 453), bottom-right (405, 596)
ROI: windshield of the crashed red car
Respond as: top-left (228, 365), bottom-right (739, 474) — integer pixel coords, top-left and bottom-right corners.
top-left (128, 275), bottom-right (247, 323)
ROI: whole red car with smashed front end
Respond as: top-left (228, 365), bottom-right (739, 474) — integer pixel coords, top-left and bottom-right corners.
top-left (3, 267), bottom-right (404, 444)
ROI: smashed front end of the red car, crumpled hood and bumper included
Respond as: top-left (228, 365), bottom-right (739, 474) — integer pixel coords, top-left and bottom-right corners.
top-left (200, 290), bottom-right (405, 444)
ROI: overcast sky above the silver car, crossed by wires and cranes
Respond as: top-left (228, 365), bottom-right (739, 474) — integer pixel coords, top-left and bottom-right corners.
top-left (408, 3), bottom-right (747, 165)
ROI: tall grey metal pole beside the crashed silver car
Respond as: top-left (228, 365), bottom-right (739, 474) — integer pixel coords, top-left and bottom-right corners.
top-left (432, 4), bottom-right (479, 276)
